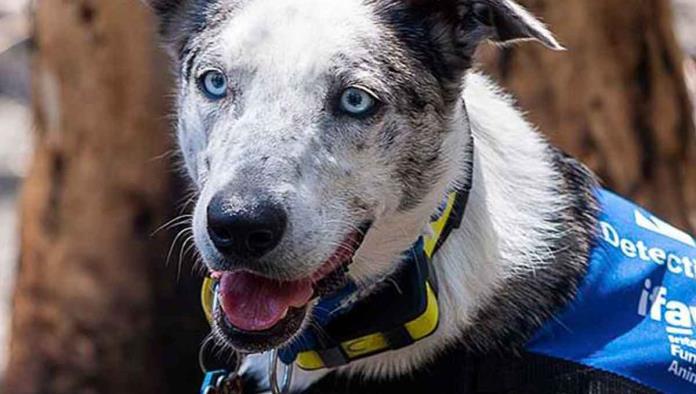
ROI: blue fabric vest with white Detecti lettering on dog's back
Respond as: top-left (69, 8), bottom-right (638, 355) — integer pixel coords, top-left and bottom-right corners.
top-left (527, 191), bottom-right (696, 393)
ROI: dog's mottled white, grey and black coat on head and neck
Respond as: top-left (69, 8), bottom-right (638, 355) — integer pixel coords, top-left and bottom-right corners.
top-left (144, 0), bottom-right (656, 394)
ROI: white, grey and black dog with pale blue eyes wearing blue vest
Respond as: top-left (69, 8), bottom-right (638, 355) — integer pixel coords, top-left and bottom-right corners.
top-left (146, 0), bottom-right (696, 393)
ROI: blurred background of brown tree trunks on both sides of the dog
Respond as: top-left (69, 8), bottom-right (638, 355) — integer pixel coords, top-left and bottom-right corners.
top-left (0, 0), bottom-right (696, 394)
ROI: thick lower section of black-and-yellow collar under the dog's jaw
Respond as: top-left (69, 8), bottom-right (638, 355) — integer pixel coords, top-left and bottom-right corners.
top-left (280, 240), bottom-right (439, 370)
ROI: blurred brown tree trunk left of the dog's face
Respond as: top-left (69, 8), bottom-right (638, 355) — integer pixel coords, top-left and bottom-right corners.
top-left (5, 0), bottom-right (205, 394)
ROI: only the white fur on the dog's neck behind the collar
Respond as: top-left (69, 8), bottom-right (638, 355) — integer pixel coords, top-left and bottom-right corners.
top-left (243, 73), bottom-right (567, 389)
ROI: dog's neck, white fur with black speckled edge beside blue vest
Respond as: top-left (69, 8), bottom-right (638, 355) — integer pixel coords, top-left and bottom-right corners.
top-left (241, 73), bottom-right (596, 388)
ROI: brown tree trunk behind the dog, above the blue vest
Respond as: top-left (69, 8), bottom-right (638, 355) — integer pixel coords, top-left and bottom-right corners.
top-left (482, 0), bottom-right (696, 230)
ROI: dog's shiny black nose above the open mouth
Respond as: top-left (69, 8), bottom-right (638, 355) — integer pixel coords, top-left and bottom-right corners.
top-left (208, 193), bottom-right (288, 259)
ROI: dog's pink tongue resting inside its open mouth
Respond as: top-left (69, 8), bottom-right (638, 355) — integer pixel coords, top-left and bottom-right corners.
top-left (219, 272), bottom-right (313, 331)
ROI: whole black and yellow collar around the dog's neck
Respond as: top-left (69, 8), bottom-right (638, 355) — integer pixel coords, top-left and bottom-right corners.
top-left (201, 190), bottom-right (469, 392)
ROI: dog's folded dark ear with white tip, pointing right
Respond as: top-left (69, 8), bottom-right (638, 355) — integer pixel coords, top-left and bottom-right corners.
top-left (402, 0), bottom-right (564, 50)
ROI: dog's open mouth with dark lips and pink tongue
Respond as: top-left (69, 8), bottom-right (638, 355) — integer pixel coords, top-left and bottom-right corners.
top-left (213, 226), bottom-right (369, 351)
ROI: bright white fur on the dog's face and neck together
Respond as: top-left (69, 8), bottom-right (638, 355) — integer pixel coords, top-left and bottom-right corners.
top-left (151, 0), bottom-right (569, 390)
